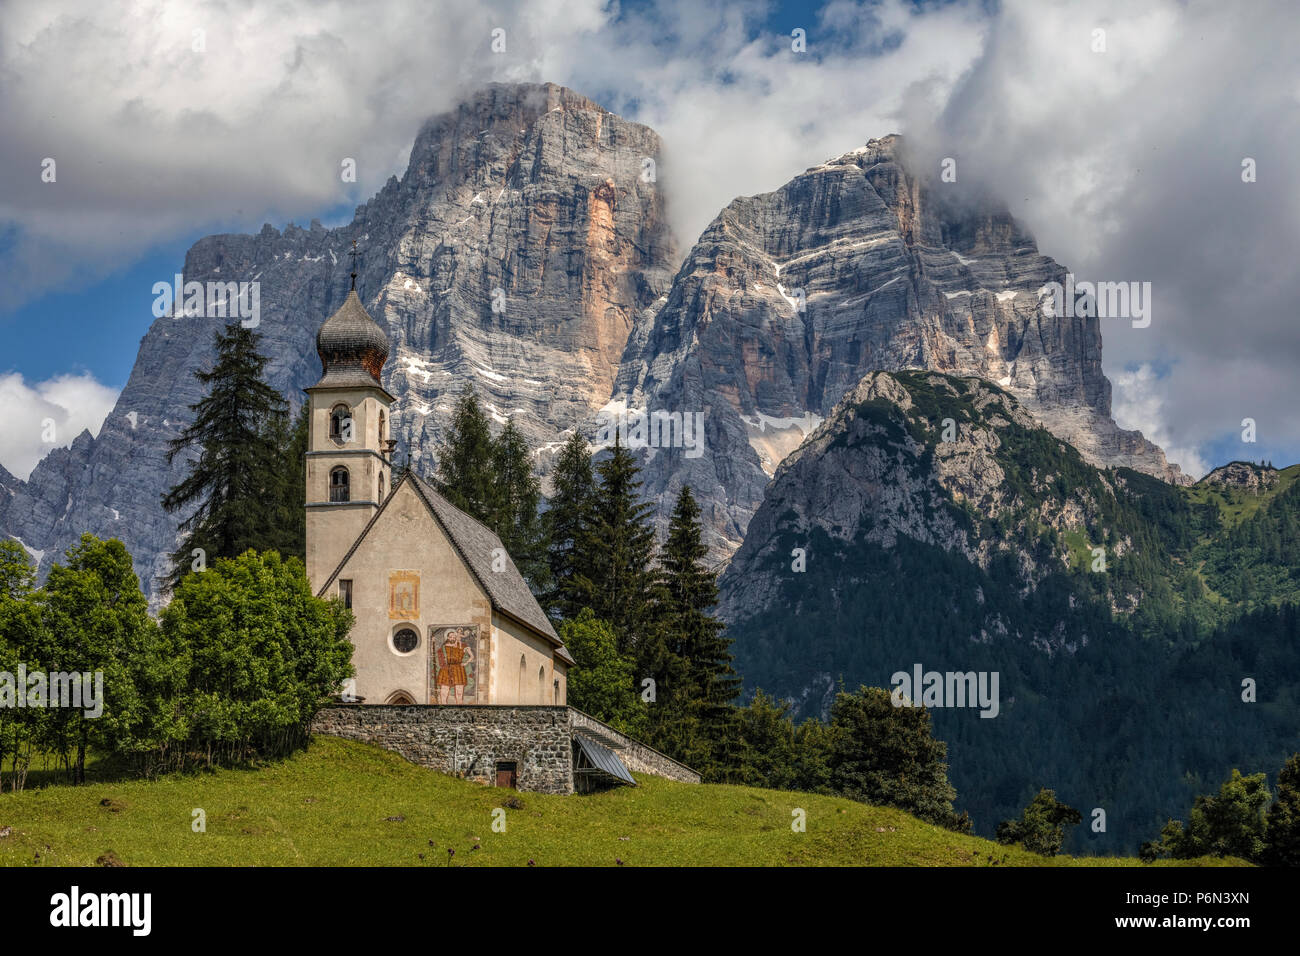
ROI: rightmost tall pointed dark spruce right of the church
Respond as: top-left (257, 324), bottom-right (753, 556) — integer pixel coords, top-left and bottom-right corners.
top-left (646, 486), bottom-right (740, 775)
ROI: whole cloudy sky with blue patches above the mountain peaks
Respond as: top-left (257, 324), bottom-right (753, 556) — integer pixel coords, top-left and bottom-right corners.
top-left (0, 0), bottom-right (1300, 476)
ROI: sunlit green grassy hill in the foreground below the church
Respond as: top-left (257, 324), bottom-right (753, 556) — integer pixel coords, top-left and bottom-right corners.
top-left (0, 737), bottom-right (1238, 866)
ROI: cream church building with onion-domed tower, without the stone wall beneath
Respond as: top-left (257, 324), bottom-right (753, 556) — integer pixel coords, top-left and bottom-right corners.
top-left (307, 289), bottom-right (573, 705)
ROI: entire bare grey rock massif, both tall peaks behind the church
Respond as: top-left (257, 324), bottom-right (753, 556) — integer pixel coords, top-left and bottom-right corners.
top-left (0, 83), bottom-right (1179, 600)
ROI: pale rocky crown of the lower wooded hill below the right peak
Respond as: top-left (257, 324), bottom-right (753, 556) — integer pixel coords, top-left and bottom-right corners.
top-left (720, 372), bottom-right (1128, 622)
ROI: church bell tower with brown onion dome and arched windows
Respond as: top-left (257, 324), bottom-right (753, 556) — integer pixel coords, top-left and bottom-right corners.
top-left (306, 260), bottom-right (394, 591)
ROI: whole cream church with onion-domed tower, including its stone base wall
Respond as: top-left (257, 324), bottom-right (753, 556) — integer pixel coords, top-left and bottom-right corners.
top-left (306, 282), bottom-right (699, 793)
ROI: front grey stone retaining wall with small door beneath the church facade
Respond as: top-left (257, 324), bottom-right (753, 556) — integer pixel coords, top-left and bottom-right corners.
top-left (312, 704), bottom-right (573, 793)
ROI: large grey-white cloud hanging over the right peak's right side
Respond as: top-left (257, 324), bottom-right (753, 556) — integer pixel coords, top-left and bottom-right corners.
top-left (905, 0), bottom-right (1300, 471)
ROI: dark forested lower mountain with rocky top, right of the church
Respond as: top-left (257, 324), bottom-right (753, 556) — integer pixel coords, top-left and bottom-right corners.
top-left (722, 372), bottom-right (1300, 852)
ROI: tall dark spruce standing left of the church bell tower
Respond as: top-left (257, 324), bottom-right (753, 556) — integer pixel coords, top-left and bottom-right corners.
top-left (163, 323), bottom-right (287, 587)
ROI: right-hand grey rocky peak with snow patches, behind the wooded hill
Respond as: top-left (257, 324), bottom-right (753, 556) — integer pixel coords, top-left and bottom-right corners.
top-left (611, 130), bottom-right (1186, 557)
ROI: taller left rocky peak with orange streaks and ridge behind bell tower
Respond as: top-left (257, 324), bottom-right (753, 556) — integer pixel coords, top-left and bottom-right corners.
top-left (0, 83), bottom-right (676, 598)
